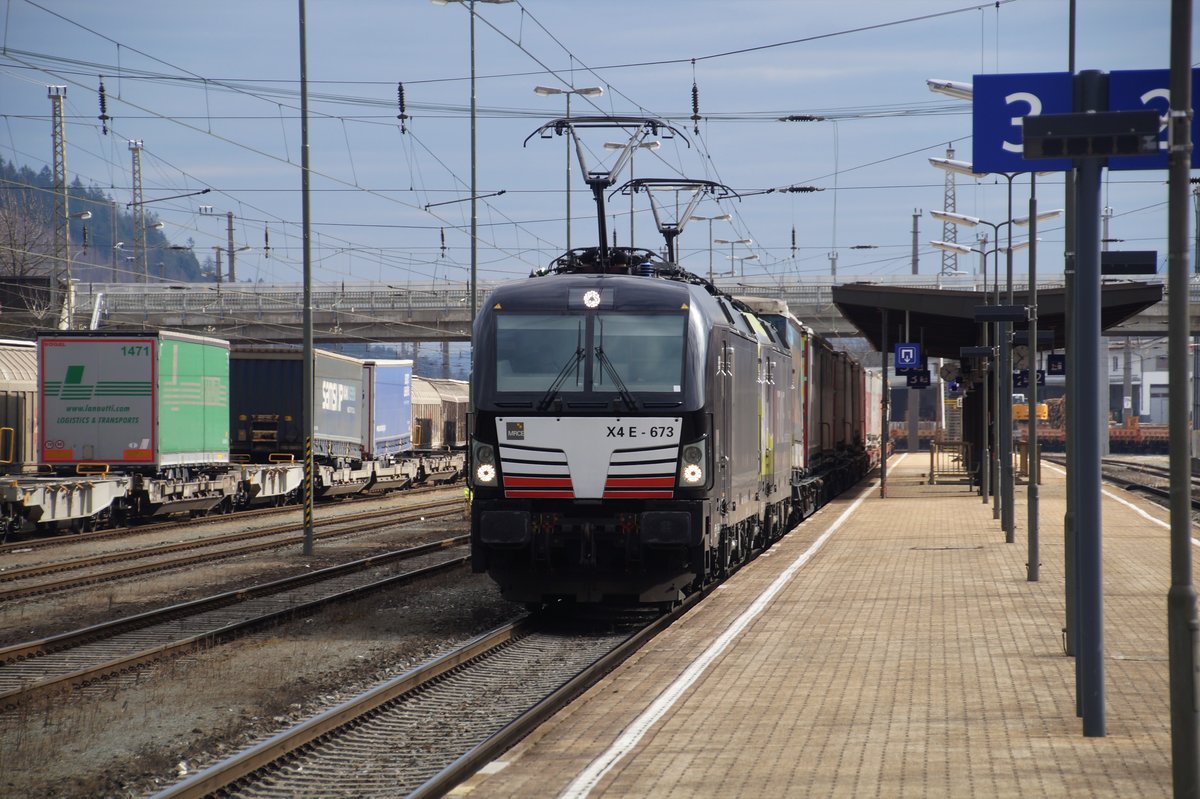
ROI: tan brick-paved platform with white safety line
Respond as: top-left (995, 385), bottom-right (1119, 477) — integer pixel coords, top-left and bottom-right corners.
top-left (451, 455), bottom-right (1196, 799)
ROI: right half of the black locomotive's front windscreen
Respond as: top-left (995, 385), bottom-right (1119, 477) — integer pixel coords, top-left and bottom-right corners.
top-left (590, 313), bottom-right (686, 395)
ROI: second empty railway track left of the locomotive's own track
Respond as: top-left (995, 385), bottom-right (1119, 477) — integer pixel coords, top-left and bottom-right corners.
top-left (0, 498), bottom-right (462, 603)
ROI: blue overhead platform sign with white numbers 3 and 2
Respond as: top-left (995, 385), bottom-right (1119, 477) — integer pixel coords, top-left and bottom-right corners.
top-left (971, 70), bottom-right (1200, 174)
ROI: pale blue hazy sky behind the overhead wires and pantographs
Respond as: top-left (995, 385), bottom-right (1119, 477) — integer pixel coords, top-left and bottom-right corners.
top-left (0, 0), bottom-right (1200, 287)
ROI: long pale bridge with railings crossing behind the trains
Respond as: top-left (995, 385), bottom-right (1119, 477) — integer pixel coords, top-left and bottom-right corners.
top-left (0, 275), bottom-right (1200, 343)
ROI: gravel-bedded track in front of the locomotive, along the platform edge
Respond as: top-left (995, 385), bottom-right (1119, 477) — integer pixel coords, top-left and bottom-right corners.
top-left (156, 596), bottom-right (698, 799)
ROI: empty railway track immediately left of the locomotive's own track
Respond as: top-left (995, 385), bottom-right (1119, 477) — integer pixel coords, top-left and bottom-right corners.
top-left (0, 536), bottom-right (468, 710)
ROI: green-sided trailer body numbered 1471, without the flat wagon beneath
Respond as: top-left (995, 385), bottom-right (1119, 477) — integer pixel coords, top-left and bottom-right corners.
top-left (37, 330), bottom-right (229, 471)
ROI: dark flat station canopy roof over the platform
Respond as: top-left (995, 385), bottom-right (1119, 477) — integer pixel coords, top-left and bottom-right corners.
top-left (833, 281), bottom-right (1163, 359)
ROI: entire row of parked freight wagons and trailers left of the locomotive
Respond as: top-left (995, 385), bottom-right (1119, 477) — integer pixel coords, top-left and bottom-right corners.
top-left (0, 331), bottom-right (466, 539)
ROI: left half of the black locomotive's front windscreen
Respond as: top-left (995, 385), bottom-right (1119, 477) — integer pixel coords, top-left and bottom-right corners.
top-left (496, 313), bottom-right (586, 394)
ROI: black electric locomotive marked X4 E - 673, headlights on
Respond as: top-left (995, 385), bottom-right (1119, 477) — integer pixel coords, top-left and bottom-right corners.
top-left (469, 251), bottom-right (796, 606)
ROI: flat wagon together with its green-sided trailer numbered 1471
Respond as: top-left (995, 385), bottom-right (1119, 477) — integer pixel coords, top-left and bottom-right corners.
top-left (33, 331), bottom-right (241, 527)
